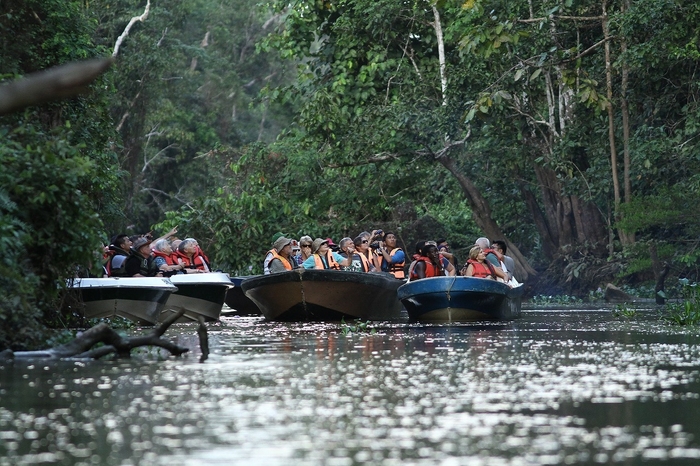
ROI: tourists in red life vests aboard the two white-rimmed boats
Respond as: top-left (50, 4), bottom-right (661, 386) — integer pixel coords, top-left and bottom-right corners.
top-left (103, 228), bottom-right (211, 277)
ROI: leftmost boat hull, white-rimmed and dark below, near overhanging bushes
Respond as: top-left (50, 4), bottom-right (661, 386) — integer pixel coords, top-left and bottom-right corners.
top-left (68, 277), bottom-right (177, 325)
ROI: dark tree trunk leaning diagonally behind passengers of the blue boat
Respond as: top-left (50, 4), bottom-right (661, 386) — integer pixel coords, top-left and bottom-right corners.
top-left (437, 155), bottom-right (537, 282)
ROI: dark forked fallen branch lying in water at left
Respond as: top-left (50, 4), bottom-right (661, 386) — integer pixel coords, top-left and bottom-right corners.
top-left (0, 309), bottom-right (189, 361)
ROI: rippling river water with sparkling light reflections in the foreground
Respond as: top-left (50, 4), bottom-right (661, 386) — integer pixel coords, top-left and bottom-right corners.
top-left (0, 309), bottom-right (700, 466)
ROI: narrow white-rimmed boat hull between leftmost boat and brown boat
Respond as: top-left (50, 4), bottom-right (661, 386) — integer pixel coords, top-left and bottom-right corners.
top-left (160, 272), bottom-right (233, 322)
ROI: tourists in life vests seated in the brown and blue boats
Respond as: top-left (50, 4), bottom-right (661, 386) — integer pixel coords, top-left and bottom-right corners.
top-left (263, 230), bottom-right (519, 286)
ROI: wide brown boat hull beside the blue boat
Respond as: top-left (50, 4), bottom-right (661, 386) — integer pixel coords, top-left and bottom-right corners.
top-left (241, 269), bottom-right (403, 322)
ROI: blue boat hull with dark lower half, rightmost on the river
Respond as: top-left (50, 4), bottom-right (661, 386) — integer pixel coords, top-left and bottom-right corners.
top-left (397, 277), bottom-right (523, 322)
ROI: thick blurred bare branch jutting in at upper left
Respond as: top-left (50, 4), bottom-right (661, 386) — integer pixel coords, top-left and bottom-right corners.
top-left (0, 58), bottom-right (112, 115)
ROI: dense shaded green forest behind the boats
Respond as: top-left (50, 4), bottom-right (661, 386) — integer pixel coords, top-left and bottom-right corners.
top-left (0, 0), bottom-right (700, 346)
